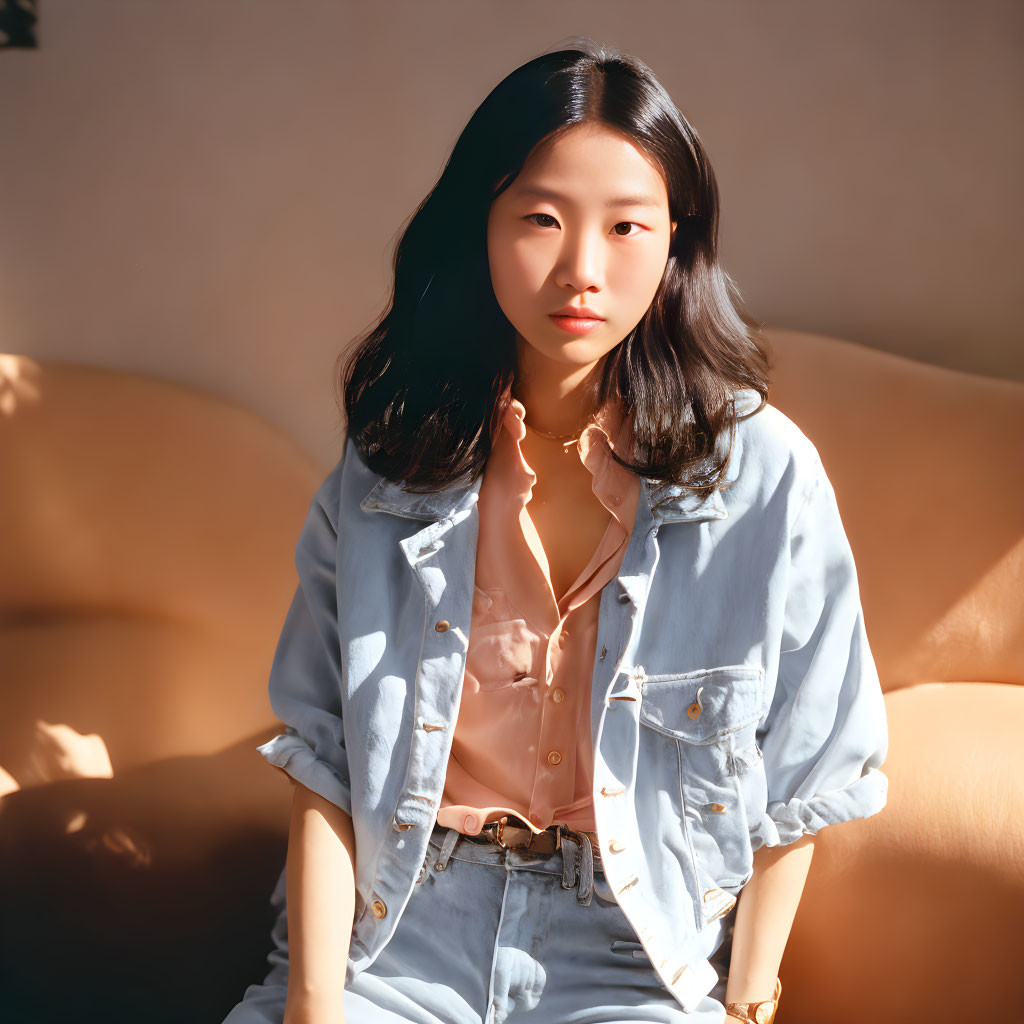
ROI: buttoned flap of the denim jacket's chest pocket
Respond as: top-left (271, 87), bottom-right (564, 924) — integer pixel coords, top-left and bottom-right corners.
top-left (640, 665), bottom-right (764, 743)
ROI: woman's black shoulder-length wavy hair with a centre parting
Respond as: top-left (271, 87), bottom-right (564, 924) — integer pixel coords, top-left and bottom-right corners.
top-left (335, 41), bottom-right (770, 496)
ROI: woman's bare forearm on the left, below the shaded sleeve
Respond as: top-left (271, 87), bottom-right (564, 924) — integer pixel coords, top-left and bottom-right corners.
top-left (285, 782), bottom-right (355, 1024)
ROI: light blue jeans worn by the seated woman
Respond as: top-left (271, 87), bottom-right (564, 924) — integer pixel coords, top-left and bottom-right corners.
top-left (223, 825), bottom-right (735, 1024)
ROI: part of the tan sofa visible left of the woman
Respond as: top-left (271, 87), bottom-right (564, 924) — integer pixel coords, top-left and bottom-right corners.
top-left (0, 356), bottom-right (324, 1024)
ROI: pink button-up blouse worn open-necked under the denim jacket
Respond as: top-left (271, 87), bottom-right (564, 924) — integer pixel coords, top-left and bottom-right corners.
top-left (437, 399), bottom-right (641, 835)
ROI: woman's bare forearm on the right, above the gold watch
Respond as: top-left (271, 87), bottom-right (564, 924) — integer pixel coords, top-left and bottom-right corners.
top-left (725, 835), bottom-right (814, 1002)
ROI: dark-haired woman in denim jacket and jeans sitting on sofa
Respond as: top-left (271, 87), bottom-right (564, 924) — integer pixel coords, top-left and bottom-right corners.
top-left (225, 37), bottom-right (887, 1024)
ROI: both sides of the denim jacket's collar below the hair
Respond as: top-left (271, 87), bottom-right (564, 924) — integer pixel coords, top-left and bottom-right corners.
top-left (359, 474), bottom-right (729, 525)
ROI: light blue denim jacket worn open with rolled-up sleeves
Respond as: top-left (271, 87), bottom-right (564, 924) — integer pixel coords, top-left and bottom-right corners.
top-left (258, 389), bottom-right (888, 1012)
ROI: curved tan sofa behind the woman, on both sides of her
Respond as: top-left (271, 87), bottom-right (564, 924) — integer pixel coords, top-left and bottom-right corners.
top-left (0, 331), bottom-right (1024, 1024)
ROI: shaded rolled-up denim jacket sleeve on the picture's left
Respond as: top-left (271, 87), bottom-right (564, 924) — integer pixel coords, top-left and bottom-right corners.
top-left (257, 487), bottom-right (352, 815)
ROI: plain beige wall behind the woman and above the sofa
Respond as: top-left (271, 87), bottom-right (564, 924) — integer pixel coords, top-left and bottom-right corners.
top-left (0, 0), bottom-right (1024, 465)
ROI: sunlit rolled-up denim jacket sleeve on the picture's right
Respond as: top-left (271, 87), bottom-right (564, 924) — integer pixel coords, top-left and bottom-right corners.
top-left (751, 460), bottom-right (889, 850)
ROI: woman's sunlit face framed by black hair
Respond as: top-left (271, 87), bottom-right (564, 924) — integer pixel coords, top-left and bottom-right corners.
top-left (487, 124), bottom-right (676, 370)
